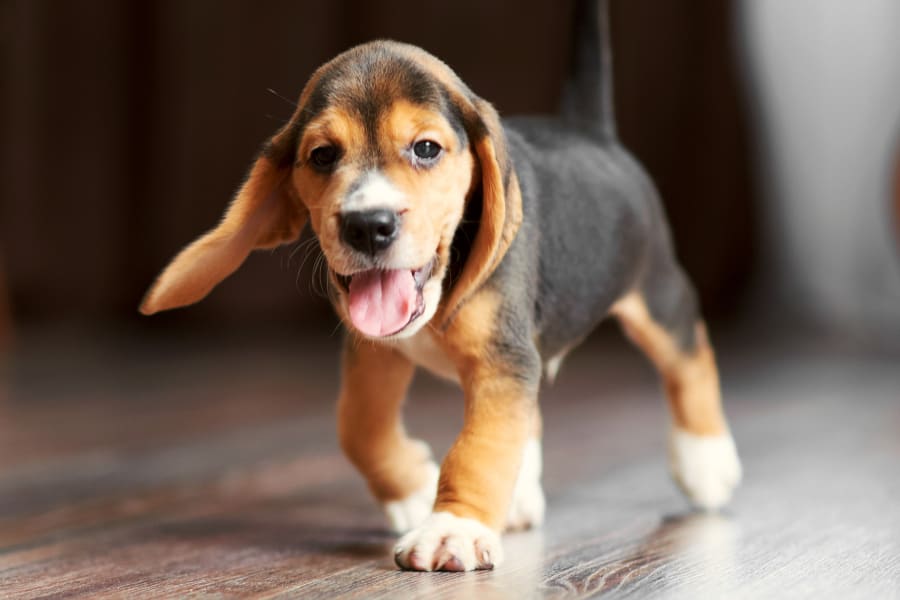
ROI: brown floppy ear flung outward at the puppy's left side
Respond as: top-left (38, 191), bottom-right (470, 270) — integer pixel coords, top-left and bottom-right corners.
top-left (140, 132), bottom-right (308, 315)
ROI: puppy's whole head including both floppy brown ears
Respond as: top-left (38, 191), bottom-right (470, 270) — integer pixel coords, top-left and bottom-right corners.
top-left (141, 42), bottom-right (522, 338)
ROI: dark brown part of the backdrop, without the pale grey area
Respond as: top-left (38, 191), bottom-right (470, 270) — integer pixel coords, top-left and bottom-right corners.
top-left (0, 0), bottom-right (754, 326)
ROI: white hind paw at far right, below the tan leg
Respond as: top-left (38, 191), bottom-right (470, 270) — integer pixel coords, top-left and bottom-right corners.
top-left (669, 427), bottom-right (741, 510)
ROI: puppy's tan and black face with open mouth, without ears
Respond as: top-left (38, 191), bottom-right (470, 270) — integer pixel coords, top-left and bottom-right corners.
top-left (292, 51), bottom-right (475, 338)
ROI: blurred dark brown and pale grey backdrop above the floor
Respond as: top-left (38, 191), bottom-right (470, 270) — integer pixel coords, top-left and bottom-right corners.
top-left (0, 0), bottom-right (900, 346)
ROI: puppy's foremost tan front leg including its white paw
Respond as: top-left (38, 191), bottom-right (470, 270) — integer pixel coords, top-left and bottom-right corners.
top-left (394, 342), bottom-right (540, 571)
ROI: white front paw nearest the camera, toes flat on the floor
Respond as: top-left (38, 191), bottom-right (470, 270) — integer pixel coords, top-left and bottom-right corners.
top-left (394, 512), bottom-right (503, 571)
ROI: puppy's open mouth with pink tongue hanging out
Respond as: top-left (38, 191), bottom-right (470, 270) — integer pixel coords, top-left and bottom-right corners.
top-left (336, 257), bottom-right (436, 337)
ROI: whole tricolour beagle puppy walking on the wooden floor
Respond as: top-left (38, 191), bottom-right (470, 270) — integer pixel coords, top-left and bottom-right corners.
top-left (141, 0), bottom-right (741, 571)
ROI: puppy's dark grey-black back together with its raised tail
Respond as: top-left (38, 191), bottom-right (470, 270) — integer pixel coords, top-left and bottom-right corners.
top-left (501, 0), bottom-right (671, 360)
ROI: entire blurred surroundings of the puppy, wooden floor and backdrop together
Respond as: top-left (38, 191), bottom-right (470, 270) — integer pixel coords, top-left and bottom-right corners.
top-left (0, 0), bottom-right (900, 598)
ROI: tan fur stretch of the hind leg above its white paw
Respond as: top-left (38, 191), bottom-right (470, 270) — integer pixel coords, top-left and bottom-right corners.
top-left (611, 293), bottom-right (727, 435)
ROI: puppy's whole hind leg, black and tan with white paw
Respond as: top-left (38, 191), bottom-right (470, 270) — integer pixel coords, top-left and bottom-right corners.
top-left (611, 255), bottom-right (741, 509)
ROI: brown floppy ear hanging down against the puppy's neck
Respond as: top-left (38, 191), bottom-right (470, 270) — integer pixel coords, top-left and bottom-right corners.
top-left (442, 98), bottom-right (522, 327)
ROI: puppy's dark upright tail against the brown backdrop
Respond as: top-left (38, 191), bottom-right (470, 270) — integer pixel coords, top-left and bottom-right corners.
top-left (562, 0), bottom-right (616, 139)
